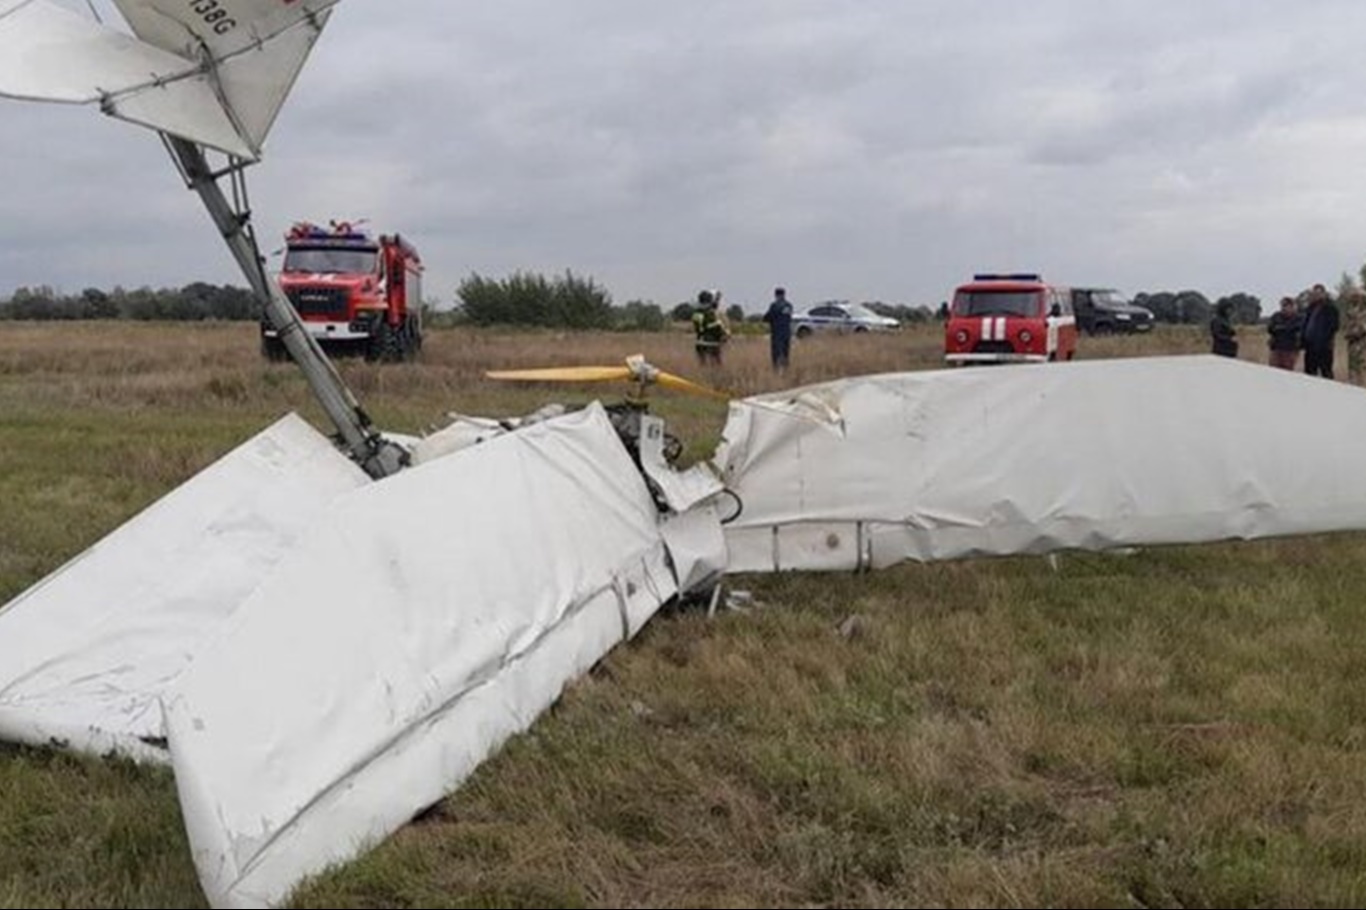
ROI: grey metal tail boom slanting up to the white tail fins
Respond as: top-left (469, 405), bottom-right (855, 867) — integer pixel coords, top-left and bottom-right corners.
top-left (163, 134), bottom-right (408, 480)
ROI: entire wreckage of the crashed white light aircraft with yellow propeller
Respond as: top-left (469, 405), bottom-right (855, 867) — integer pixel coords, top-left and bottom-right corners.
top-left (0, 0), bottom-right (1366, 907)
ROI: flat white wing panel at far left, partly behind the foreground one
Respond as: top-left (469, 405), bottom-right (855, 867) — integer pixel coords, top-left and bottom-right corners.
top-left (0, 414), bottom-right (370, 762)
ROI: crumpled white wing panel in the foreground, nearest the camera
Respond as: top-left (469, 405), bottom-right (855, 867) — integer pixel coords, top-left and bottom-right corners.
top-left (167, 404), bottom-right (688, 907)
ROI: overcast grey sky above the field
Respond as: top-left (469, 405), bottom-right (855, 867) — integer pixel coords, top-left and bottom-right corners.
top-left (0, 0), bottom-right (1366, 312)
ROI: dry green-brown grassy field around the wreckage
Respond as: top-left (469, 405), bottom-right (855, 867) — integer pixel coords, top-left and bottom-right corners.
top-left (0, 315), bottom-right (1366, 907)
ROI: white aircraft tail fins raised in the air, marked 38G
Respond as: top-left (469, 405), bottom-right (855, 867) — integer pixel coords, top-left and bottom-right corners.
top-left (0, 0), bottom-right (337, 161)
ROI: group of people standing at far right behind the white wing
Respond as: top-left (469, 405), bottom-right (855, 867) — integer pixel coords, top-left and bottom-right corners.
top-left (1209, 284), bottom-right (1366, 385)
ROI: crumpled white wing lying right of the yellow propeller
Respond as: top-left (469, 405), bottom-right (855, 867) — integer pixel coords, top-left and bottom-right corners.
top-left (717, 357), bottom-right (1366, 571)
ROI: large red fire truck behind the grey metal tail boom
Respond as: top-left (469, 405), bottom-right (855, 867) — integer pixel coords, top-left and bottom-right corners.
top-left (261, 221), bottom-right (422, 361)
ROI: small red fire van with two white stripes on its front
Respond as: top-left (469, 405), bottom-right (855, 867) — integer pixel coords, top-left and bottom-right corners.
top-left (944, 273), bottom-right (1076, 366)
